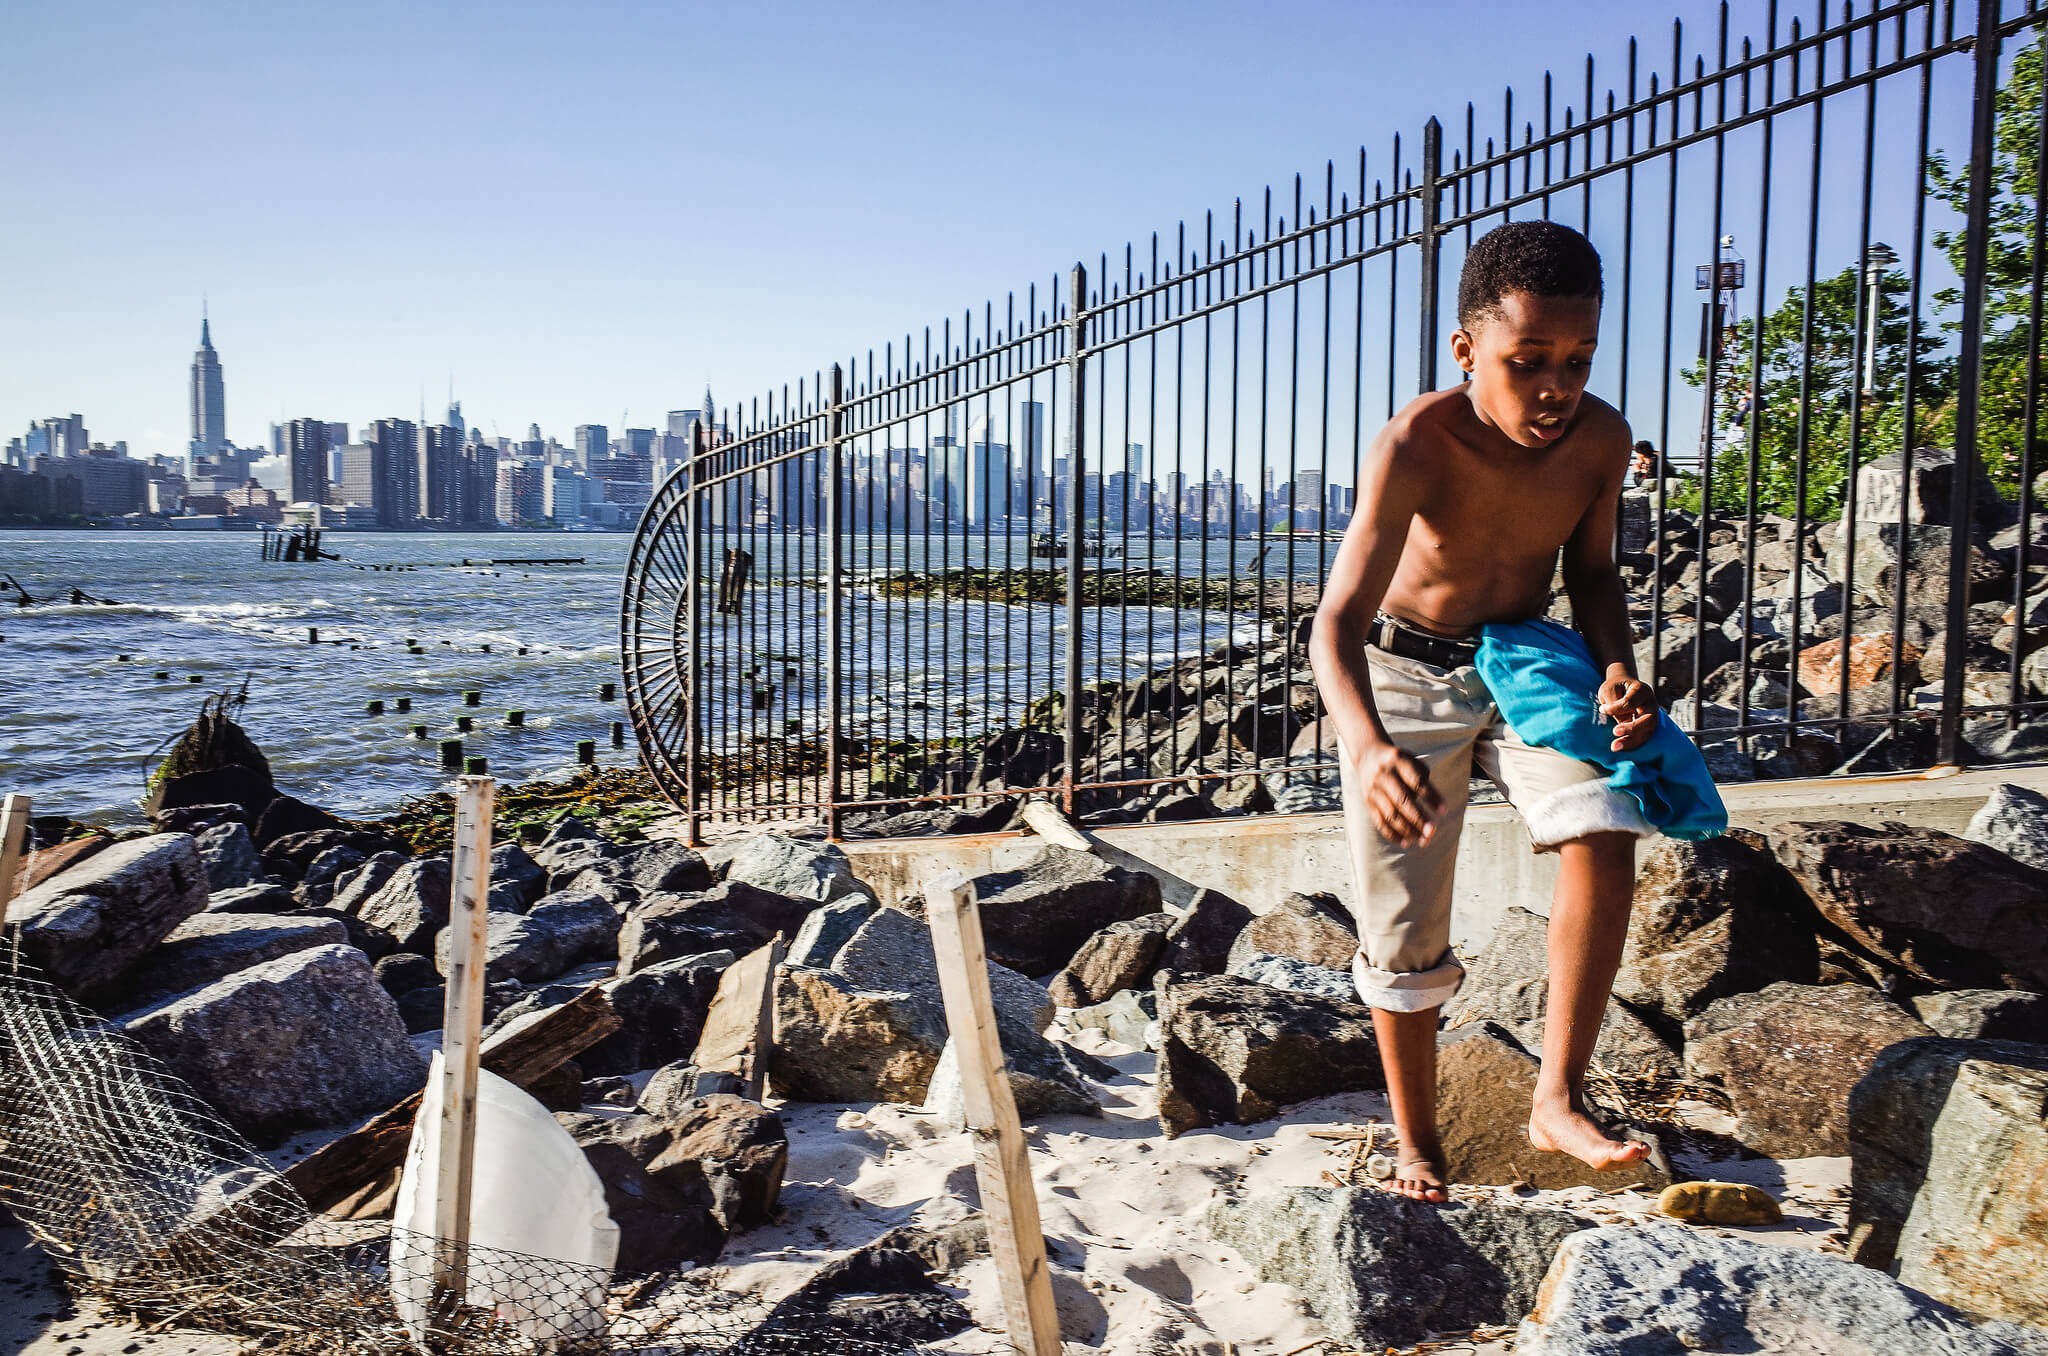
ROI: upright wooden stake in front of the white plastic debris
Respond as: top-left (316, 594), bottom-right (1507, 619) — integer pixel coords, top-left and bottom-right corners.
top-left (434, 776), bottom-right (498, 1311)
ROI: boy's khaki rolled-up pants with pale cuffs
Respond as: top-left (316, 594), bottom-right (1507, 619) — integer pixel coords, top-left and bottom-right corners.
top-left (1339, 647), bottom-right (1657, 1012)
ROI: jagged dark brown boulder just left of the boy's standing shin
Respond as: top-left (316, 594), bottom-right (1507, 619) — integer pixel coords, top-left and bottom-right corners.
top-left (1159, 975), bottom-right (1386, 1137)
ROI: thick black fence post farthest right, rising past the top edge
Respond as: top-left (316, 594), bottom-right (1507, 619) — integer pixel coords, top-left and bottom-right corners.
top-left (1941, 0), bottom-right (1999, 768)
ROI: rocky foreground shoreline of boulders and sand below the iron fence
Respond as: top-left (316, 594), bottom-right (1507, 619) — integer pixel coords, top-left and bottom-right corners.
top-left (10, 700), bottom-right (2048, 1352)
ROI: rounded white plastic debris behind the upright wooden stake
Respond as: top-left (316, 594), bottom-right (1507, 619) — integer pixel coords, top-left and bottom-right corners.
top-left (391, 1051), bottom-right (618, 1350)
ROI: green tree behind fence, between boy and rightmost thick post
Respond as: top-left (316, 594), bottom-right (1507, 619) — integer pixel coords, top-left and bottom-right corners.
top-left (1683, 266), bottom-right (1954, 520)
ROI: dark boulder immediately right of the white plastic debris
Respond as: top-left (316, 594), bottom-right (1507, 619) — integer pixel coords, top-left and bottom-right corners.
top-left (555, 1112), bottom-right (725, 1274)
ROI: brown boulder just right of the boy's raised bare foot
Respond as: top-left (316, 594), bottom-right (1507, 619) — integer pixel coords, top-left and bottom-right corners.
top-left (1686, 983), bottom-right (1931, 1157)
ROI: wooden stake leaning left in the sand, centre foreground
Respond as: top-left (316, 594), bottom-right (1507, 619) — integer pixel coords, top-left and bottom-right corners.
top-left (924, 871), bottom-right (1061, 1356)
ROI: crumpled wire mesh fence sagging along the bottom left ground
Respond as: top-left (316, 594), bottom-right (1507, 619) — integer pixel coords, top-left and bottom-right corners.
top-left (0, 940), bottom-right (937, 1356)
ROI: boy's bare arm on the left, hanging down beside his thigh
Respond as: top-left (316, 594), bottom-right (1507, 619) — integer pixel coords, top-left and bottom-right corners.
top-left (1309, 424), bottom-right (1442, 846)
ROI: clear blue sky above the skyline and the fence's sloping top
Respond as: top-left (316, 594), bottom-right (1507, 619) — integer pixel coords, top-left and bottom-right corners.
top-left (0, 0), bottom-right (1982, 455)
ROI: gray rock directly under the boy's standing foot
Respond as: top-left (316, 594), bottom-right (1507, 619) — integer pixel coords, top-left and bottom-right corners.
top-left (1204, 1186), bottom-right (1587, 1350)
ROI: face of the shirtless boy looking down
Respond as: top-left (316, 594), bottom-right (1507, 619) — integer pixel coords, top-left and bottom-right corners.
top-left (1450, 291), bottom-right (1599, 447)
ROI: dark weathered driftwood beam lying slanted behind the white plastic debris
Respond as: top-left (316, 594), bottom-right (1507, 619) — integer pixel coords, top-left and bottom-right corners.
top-left (285, 985), bottom-right (621, 1211)
